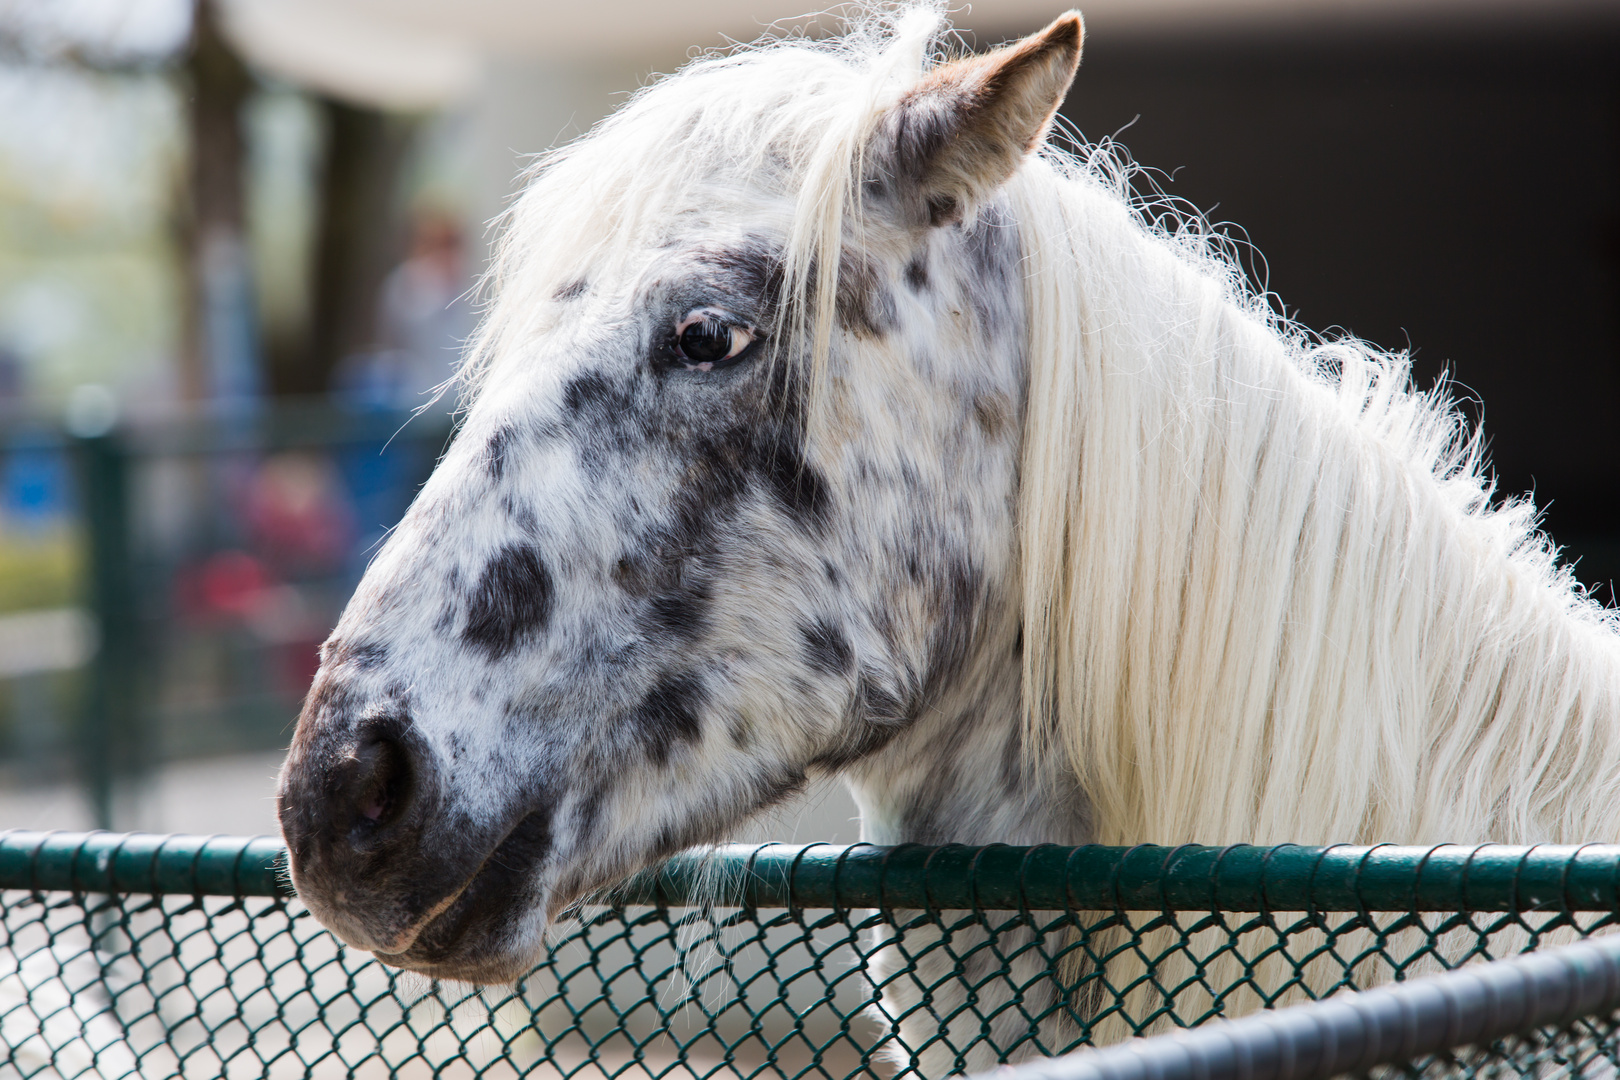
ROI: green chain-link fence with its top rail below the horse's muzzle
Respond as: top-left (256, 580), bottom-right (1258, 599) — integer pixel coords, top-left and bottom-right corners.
top-left (0, 832), bottom-right (1620, 1080)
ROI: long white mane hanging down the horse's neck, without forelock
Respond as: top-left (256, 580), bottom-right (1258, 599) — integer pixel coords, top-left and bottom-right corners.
top-left (1013, 151), bottom-right (1620, 844)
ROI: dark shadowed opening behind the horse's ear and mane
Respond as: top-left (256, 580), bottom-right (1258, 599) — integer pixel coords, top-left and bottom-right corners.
top-left (1066, 24), bottom-right (1620, 602)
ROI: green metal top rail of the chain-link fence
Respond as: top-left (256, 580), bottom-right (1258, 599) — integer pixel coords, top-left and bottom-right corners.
top-left (15, 829), bottom-right (1620, 913)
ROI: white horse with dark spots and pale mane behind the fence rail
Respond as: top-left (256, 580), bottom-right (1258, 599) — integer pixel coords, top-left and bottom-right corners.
top-left (279, 3), bottom-right (1620, 1075)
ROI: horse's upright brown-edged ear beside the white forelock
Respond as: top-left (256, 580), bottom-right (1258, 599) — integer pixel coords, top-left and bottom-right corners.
top-left (867, 11), bottom-right (1085, 225)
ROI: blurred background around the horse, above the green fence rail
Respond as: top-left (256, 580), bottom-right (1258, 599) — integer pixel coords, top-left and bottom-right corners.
top-left (0, 0), bottom-right (1620, 840)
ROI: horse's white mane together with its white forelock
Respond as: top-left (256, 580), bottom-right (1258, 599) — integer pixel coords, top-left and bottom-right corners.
top-left (465, 5), bottom-right (1620, 844)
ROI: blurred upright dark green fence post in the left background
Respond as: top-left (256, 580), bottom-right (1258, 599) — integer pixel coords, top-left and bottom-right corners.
top-left (75, 432), bottom-right (146, 829)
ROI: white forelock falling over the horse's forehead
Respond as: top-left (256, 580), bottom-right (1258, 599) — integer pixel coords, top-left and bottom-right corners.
top-left (460, 0), bottom-right (948, 404)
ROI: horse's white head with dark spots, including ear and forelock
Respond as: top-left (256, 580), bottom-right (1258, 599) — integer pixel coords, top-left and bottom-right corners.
top-left (279, 15), bottom-right (1081, 981)
